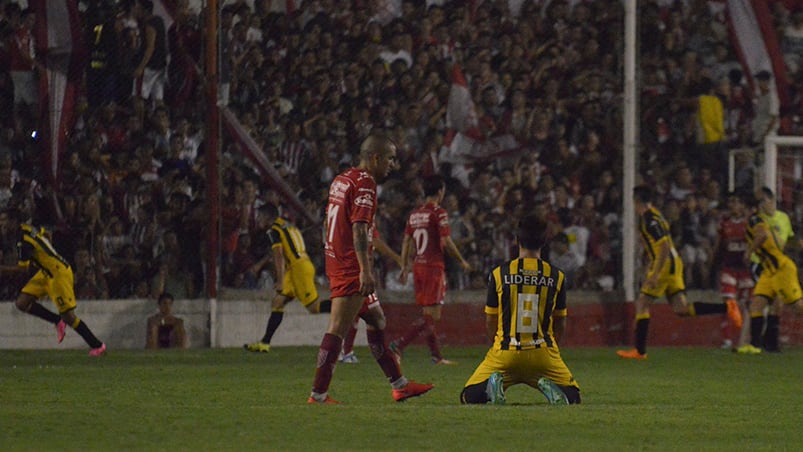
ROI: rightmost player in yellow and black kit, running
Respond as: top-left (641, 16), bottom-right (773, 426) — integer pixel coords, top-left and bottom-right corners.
top-left (737, 192), bottom-right (803, 354)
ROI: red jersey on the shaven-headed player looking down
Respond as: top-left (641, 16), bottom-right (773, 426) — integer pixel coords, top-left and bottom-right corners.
top-left (324, 168), bottom-right (377, 281)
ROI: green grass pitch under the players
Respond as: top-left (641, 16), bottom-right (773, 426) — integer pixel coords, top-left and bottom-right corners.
top-left (0, 347), bottom-right (803, 451)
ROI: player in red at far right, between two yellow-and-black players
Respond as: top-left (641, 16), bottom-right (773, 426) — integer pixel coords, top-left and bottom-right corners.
top-left (714, 193), bottom-right (755, 347)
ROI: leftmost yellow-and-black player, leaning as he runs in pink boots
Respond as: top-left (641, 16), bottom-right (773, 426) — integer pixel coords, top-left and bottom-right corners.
top-left (4, 209), bottom-right (106, 356)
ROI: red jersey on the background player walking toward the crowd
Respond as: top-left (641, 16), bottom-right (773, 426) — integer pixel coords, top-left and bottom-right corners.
top-left (404, 202), bottom-right (452, 268)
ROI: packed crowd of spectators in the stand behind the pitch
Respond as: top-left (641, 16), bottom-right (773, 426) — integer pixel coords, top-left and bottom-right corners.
top-left (0, 0), bottom-right (803, 299)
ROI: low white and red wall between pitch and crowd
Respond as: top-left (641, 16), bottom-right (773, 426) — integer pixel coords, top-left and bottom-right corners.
top-left (0, 291), bottom-right (803, 349)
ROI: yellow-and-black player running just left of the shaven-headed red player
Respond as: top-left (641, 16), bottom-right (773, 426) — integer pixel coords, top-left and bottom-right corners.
top-left (243, 204), bottom-right (332, 352)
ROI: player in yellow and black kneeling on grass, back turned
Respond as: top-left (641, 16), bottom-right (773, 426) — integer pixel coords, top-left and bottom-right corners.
top-left (460, 215), bottom-right (580, 405)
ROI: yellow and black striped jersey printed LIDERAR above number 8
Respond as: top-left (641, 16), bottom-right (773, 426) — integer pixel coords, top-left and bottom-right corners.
top-left (485, 258), bottom-right (566, 350)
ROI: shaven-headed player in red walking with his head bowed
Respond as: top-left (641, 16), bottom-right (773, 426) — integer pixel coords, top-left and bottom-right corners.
top-left (307, 133), bottom-right (433, 404)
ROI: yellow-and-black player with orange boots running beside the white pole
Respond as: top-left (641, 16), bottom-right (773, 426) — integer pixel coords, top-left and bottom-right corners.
top-left (616, 185), bottom-right (742, 359)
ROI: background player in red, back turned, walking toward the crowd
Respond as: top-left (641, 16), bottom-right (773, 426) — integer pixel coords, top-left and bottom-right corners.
top-left (390, 176), bottom-right (471, 364)
